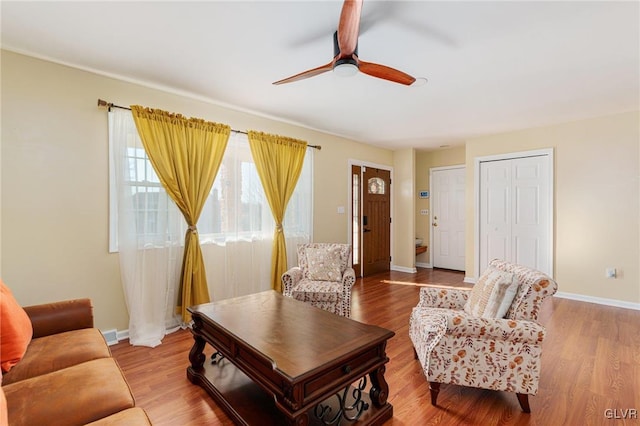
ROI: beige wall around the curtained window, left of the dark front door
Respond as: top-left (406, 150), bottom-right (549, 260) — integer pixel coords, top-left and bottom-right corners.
top-left (0, 51), bottom-right (393, 330)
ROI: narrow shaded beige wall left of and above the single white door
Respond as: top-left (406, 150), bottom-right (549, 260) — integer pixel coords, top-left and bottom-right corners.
top-left (414, 146), bottom-right (465, 265)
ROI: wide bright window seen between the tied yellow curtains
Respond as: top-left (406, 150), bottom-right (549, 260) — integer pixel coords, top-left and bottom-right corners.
top-left (109, 113), bottom-right (313, 252)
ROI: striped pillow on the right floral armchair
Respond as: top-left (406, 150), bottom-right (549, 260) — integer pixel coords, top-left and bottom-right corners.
top-left (464, 266), bottom-right (518, 318)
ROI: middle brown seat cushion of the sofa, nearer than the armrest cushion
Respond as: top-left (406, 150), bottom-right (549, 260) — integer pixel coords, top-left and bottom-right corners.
top-left (3, 358), bottom-right (134, 426)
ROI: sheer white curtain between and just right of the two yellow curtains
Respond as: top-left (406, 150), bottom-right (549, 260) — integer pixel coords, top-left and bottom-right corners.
top-left (198, 133), bottom-right (313, 300)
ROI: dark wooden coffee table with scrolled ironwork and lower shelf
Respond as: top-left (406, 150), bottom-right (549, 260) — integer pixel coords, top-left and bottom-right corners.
top-left (187, 291), bottom-right (395, 425)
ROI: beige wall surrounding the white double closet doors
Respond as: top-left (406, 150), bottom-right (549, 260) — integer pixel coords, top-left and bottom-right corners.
top-left (466, 111), bottom-right (640, 304)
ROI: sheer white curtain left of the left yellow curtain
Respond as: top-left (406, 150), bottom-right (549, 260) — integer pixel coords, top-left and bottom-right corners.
top-left (109, 109), bottom-right (185, 347)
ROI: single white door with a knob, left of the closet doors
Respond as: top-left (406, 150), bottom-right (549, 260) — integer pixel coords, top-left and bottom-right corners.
top-left (431, 167), bottom-right (465, 271)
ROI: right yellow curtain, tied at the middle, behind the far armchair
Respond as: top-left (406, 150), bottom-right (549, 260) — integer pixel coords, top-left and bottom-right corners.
top-left (248, 131), bottom-right (307, 293)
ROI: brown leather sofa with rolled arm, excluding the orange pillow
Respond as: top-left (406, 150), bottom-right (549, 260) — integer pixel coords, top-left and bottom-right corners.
top-left (2, 299), bottom-right (151, 426)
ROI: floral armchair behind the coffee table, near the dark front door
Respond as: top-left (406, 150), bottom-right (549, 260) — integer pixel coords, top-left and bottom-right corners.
top-left (282, 243), bottom-right (356, 317)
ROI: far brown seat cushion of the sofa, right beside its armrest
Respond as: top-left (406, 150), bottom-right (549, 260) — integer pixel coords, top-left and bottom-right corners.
top-left (3, 328), bottom-right (111, 384)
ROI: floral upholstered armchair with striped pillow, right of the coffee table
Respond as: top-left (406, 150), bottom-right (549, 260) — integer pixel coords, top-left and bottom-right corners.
top-left (409, 259), bottom-right (558, 413)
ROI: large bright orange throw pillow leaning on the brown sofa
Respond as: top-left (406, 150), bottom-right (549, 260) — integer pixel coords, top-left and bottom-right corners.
top-left (0, 279), bottom-right (33, 373)
